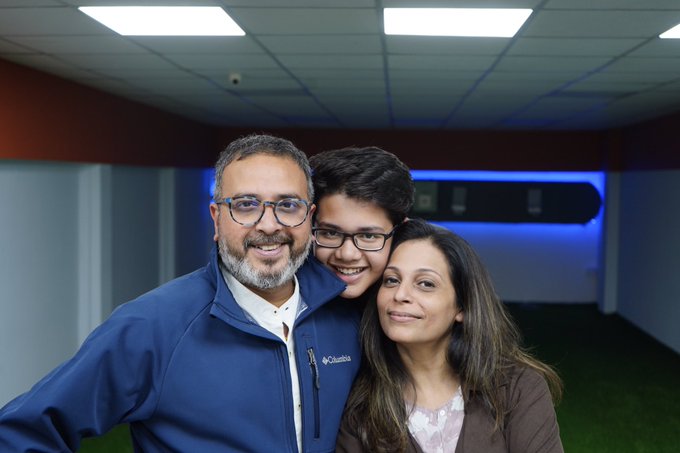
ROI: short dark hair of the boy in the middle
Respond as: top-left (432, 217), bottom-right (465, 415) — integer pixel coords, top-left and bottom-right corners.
top-left (309, 146), bottom-right (415, 225)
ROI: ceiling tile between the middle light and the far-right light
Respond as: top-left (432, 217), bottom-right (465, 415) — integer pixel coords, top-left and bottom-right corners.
top-left (522, 10), bottom-right (680, 38)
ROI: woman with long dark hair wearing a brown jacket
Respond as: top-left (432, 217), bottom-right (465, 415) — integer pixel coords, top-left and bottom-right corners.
top-left (337, 220), bottom-right (563, 453)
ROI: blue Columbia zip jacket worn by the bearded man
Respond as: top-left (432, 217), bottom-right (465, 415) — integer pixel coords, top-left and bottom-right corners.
top-left (0, 250), bottom-right (361, 453)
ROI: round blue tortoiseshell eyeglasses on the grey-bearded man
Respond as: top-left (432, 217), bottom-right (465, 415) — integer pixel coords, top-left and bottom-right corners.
top-left (215, 197), bottom-right (309, 227)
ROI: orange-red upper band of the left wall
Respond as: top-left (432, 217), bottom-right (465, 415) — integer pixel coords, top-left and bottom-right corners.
top-left (0, 60), bottom-right (219, 166)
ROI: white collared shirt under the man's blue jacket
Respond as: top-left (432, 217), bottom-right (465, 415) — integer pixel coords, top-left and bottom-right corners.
top-left (220, 266), bottom-right (302, 451)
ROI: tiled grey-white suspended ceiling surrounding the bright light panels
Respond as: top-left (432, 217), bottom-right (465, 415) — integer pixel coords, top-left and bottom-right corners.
top-left (0, 0), bottom-right (680, 130)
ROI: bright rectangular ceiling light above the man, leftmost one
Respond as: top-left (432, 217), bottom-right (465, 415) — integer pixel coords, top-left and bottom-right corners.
top-left (78, 6), bottom-right (245, 36)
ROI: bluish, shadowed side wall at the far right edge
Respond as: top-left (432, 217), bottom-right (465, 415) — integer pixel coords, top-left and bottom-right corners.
top-left (618, 170), bottom-right (680, 353)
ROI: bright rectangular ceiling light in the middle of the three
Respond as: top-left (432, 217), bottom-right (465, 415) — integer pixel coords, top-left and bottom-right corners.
top-left (384, 8), bottom-right (532, 38)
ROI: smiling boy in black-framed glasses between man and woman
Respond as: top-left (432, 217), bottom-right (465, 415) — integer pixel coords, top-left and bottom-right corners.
top-left (310, 147), bottom-right (415, 302)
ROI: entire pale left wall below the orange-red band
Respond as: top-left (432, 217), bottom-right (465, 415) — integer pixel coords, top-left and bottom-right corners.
top-left (0, 161), bottom-right (212, 406)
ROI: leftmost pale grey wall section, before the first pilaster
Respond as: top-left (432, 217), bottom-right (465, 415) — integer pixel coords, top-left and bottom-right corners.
top-left (0, 162), bottom-right (81, 406)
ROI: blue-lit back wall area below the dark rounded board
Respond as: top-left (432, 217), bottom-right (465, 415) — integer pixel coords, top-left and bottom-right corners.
top-left (441, 218), bottom-right (601, 303)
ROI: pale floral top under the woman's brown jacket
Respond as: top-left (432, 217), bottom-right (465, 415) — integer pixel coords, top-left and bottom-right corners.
top-left (408, 387), bottom-right (465, 453)
